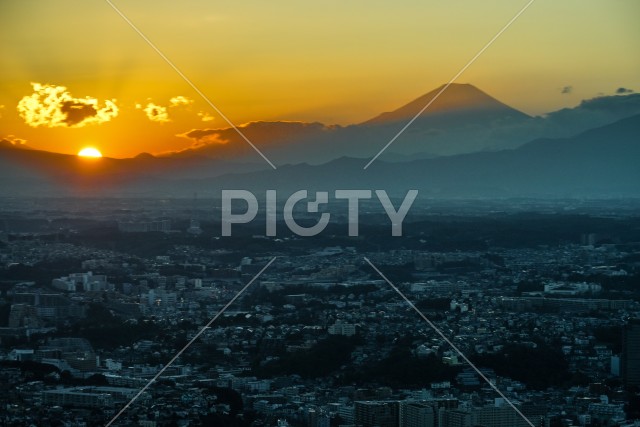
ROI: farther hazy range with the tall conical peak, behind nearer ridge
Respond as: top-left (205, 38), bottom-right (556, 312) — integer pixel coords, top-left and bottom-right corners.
top-left (169, 84), bottom-right (640, 165)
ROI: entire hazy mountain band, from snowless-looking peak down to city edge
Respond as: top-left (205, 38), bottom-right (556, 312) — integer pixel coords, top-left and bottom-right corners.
top-left (0, 85), bottom-right (640, 198)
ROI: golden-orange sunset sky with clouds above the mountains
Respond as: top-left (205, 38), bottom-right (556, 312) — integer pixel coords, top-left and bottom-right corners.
top-left (0, 0), bottom-right (640, 157)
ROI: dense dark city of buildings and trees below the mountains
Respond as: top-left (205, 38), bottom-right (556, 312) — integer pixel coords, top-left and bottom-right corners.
top-left (0, 199), bottom-right (640, 427)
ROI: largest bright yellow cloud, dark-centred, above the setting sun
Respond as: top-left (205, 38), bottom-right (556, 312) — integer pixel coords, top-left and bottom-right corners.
top-left (16, 83), bottom-right (118, 128)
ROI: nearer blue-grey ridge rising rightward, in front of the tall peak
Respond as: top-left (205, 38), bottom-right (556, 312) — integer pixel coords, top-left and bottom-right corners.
top-left (146, 115), bottom-right (640, 199)
